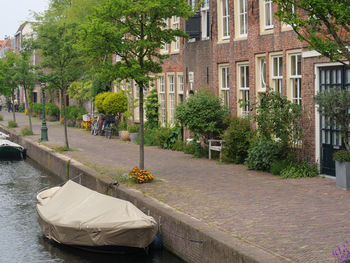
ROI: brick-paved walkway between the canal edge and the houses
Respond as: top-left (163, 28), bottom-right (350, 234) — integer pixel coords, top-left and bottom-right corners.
top-left (0, 111), bottom-right (350, 263)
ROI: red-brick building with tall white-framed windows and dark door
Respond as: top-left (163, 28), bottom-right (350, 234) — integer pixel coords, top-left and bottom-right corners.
top-left (128, 0), bottom-right (350, 175)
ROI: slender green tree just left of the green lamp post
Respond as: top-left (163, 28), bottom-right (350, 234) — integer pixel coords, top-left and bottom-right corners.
top-left (14, 41), bottom-right (36, 133)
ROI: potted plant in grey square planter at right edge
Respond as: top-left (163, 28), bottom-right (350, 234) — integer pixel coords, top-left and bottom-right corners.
top-left (314, 88), bottom-right (350, 190)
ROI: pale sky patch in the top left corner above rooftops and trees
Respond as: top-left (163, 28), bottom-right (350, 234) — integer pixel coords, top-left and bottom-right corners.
top-left (0, 0), bottom-right (49, 40)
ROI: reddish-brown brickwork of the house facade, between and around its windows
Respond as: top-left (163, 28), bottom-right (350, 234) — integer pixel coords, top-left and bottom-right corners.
top-left (157, 0), bottom-right (342, 163)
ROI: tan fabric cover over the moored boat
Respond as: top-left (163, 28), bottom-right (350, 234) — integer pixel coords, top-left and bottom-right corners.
top-left (37, 181), bottom-right (157, 248)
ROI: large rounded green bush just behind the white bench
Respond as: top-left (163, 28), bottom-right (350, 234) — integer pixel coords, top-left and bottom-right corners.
top-left (175, 91), bottom-right (229, 142)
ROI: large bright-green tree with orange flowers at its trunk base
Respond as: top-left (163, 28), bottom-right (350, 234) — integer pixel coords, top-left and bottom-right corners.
top-left (80, 0), bottom-right (192, 169)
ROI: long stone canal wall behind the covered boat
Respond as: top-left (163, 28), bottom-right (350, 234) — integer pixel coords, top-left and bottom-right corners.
top-left (0, 127), bottom-right (288, 263)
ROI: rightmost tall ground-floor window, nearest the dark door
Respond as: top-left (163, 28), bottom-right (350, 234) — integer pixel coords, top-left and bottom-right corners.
top-left (289, 54), bottom-right (301, 104)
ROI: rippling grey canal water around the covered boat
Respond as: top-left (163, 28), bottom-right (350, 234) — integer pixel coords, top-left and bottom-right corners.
top-left (0, 161), bottom-right (184, 263)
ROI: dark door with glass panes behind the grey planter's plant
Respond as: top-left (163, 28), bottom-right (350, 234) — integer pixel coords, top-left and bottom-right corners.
top-left (319, 66), bottom-right (350, 176)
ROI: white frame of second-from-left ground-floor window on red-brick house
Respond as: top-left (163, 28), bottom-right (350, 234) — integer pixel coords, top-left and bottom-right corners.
top-left (237, 63), bottom-right (250, 117)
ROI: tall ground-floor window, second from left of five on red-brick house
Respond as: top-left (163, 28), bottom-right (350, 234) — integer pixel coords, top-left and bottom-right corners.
top-left (238, 64), bottom-right (249, 117)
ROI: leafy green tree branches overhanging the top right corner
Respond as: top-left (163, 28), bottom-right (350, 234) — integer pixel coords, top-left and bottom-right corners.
top-left (273, 0), bottom-right (350, 64)
